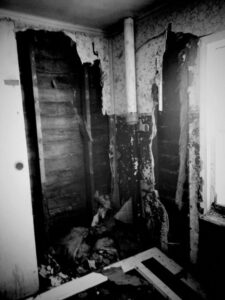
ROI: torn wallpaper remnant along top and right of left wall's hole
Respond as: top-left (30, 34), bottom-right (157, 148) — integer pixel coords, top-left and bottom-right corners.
top-left (7, 20), bottom-right (114, 115)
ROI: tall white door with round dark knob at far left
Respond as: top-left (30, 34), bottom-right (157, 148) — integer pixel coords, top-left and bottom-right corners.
top-left (0, 21), bottom-right (38, 299)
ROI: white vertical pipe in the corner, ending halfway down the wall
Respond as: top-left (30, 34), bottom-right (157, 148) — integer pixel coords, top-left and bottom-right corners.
top-left (124, 17), bottom-right (137, 124)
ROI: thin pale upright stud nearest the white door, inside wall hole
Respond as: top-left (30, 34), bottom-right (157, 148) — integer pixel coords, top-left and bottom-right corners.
top-left (30, 46), bottom-right (49, 232)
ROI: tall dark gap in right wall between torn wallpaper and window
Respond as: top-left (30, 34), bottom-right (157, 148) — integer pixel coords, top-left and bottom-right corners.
top-left (156, 31), bottom-right (198, 263)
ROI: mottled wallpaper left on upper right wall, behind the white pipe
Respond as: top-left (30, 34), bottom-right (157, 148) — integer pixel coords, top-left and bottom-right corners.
top-left (113, 0), bottom-right (225, 114)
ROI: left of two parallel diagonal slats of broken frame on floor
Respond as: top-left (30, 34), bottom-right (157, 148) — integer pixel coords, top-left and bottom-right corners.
top-left (136, 262), bottom-right (181, 300)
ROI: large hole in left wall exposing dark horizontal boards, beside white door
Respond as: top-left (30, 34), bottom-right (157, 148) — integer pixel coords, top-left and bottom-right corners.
top-left (17, 30), bottom-right (110, 253)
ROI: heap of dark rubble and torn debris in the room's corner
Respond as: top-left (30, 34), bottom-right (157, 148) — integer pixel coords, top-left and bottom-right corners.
top-left (39, 197), bottom-right (149, 290)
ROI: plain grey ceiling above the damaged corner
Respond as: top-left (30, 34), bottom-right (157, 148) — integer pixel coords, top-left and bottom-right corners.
top-left (0, 0), bottom-right (166, 29)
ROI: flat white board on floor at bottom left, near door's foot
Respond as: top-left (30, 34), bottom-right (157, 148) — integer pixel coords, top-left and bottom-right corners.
top-left (27, 273), bottom-right (108, 300)
